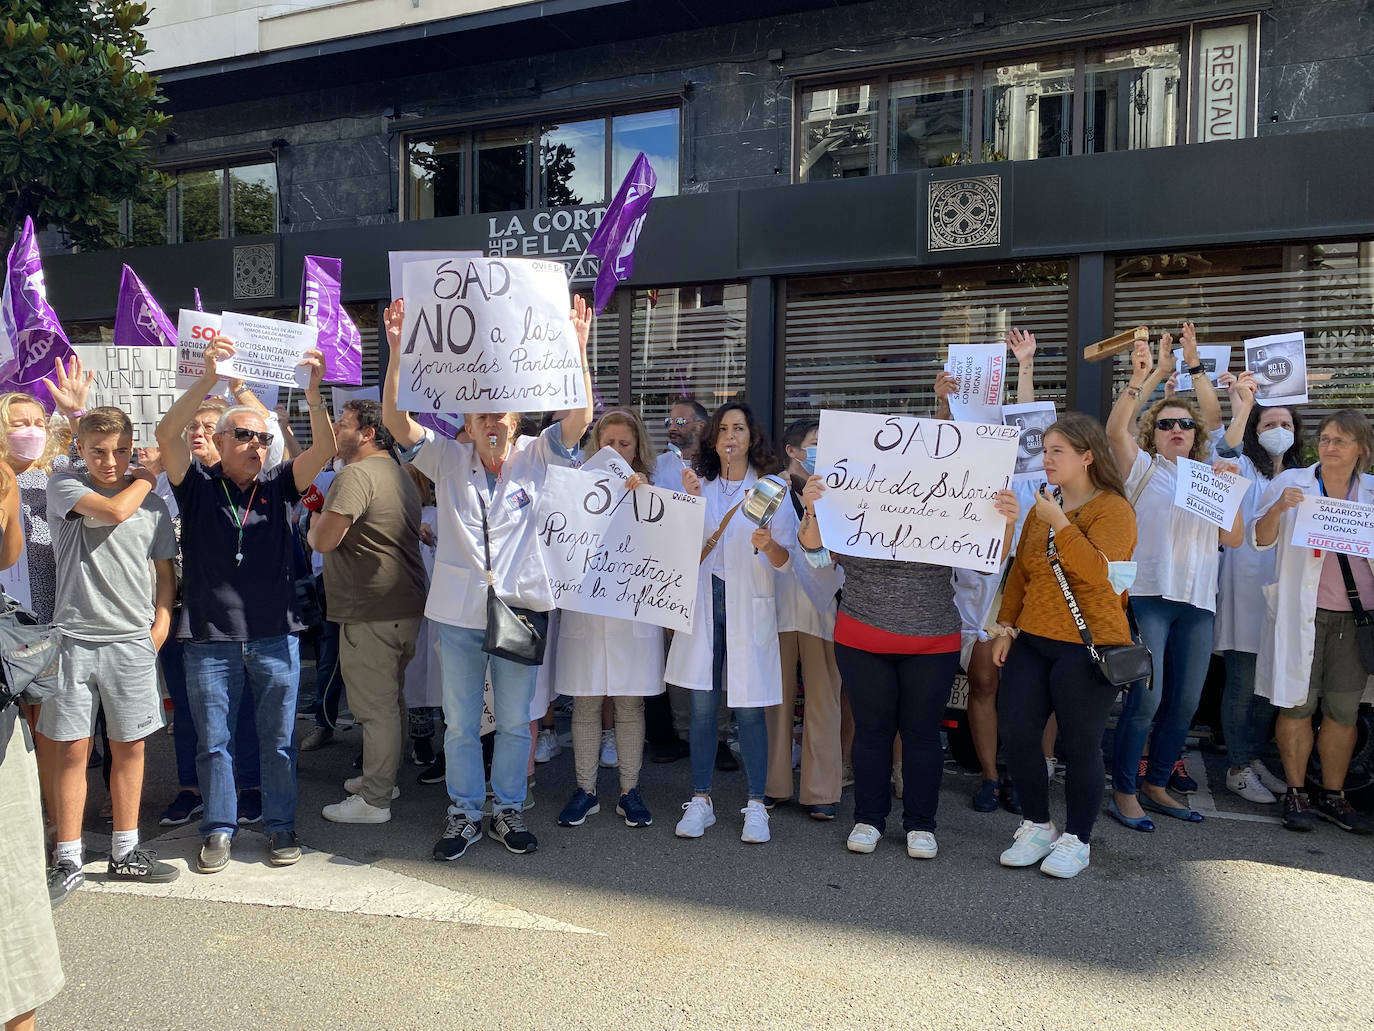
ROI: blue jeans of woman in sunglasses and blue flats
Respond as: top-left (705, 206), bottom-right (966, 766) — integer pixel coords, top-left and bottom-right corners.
top-left (1112, 597), bottom-right (1213, 795)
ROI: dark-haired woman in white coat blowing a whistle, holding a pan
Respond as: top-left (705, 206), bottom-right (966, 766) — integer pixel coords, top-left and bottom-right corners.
top-left (665, 401), bottom-right (797, 843)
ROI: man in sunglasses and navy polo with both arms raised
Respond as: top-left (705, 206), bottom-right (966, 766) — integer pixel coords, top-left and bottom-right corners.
top-left (157, 337), bottom-right (335, 873)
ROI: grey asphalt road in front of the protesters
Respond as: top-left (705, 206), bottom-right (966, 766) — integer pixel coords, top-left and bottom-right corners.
top-left (40, 731), bottom-right (1374, 1031)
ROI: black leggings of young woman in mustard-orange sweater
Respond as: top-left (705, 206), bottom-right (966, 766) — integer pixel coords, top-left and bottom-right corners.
top-left (998, 632), bottom-right (1117, 841)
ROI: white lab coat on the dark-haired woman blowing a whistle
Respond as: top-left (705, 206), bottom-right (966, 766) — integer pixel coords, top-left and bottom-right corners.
top-left (664, 469), bottom-right (797, 709)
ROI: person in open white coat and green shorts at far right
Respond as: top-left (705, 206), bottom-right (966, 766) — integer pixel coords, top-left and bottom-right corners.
top-left (1249, 408), bottom-right (1374, 834)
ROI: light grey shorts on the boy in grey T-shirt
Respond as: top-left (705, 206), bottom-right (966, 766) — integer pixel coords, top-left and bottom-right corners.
top-left (37, 636), bottom-right (165, 741)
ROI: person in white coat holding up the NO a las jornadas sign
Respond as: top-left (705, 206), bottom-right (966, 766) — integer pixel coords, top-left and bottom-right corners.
top-left (382, 296), bottom-right (592, 861)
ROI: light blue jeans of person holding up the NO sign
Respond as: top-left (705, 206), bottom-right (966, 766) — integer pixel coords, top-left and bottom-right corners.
top-left (434, 623), bottom-right (539, 821)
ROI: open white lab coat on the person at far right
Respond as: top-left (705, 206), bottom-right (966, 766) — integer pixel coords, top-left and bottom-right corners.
top-left (1245, 466), bottom-right (1374, 709)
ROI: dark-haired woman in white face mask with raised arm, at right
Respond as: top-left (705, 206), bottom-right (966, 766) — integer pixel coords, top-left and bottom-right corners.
top-left (1212, 388), bottom-right (1307, 804)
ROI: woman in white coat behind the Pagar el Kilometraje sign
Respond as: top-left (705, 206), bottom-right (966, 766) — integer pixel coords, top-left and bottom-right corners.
top-left (555, 408), bottom-right (665, 828)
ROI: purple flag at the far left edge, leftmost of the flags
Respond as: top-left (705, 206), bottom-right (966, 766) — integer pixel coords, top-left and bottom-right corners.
top-left (0, 217), bottom-right (71, 408)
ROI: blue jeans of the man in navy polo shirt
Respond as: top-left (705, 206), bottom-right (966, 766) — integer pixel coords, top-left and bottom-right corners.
top-left (185, 634), bottom-right (301, 837)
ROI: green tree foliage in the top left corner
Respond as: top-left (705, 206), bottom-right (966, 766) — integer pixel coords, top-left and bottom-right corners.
top-left (0, 0), bottom-right (170, 247)
